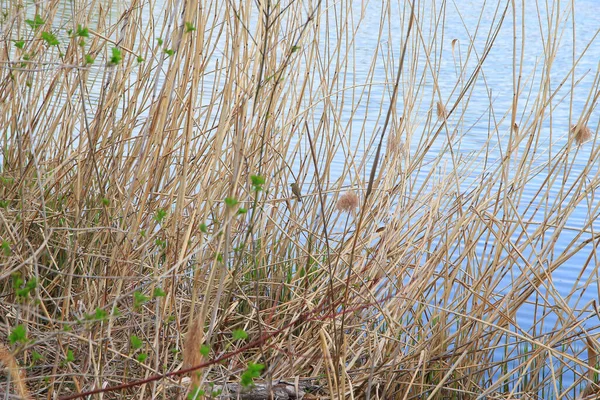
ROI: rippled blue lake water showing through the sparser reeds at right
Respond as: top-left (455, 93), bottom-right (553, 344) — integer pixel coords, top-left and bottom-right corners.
top-left (308, 1), bottom-right (600, 397)
